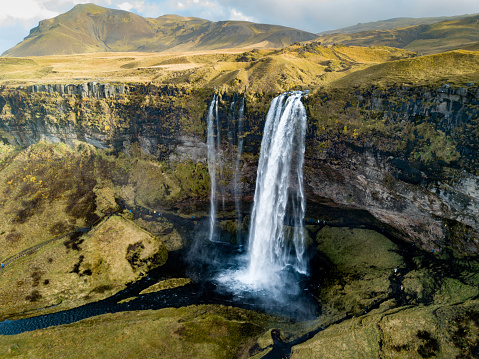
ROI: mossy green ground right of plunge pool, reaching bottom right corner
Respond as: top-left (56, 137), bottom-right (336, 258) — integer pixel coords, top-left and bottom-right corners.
top-left (284, 227), bottom-right (479, 358)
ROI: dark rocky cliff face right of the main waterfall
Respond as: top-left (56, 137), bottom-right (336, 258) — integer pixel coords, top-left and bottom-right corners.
top-left (308, 85), bottom-right (479, 253)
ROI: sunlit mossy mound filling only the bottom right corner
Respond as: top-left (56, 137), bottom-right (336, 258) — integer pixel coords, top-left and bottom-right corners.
top-left (291, 300), bottom-right (479, 358)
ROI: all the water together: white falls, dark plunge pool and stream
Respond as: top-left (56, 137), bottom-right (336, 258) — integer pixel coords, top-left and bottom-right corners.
top-left (0, 92), bottom-right (318, 335)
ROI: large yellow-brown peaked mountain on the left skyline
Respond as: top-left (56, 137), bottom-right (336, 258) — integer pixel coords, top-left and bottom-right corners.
top-left (2, 4), bottom-right (316, 57)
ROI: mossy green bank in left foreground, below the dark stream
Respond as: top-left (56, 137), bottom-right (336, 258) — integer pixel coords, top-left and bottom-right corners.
top-left (0, 305), bottom-right (271, 358)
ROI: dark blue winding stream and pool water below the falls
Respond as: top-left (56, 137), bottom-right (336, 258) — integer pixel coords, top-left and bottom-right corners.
top-left (0, 240), bottom-right (319, 335)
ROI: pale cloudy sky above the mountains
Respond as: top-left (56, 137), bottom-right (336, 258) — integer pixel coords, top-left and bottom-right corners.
top-left (0, 0), bottom-right (479, 54)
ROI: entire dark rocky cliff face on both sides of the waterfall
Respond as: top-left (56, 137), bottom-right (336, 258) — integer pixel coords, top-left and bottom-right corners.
top-left (0, 83), bottom-right (479, 254)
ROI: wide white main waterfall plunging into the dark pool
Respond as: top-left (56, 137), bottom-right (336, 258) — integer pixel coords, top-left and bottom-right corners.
top-left (247, 92), bottom-right (306, 287)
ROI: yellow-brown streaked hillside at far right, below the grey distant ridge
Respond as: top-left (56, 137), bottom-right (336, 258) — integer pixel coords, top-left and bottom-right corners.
top-left (316, 15), bottom-right (479, 54)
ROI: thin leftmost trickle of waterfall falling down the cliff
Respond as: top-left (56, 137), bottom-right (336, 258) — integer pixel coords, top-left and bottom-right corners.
top-left (206, 95), bottom-right (218, 241)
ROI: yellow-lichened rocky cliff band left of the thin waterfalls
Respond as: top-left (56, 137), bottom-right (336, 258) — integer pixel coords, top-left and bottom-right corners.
top-left (0, 82), bottom-right (201, 159)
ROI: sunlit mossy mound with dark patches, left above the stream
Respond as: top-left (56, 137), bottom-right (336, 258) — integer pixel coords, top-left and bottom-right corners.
top-left (0, 216), bottom-right (168, 318)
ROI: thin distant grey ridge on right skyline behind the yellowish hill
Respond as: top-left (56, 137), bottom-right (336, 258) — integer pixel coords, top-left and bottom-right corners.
top-left (318, 14), bottom-right (479, 36)
